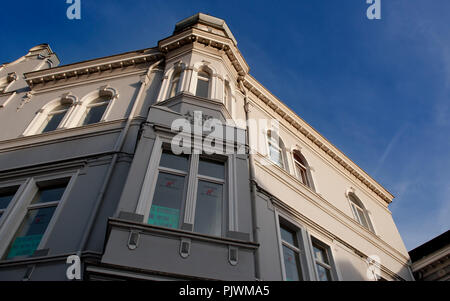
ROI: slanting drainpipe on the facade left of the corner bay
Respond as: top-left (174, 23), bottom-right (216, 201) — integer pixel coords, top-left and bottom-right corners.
top-left (77, 59), bottom-right (163, 257)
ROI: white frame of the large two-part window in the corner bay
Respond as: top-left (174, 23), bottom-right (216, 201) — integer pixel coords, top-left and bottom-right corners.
top-left (136, 135), bottom-right (238, 237)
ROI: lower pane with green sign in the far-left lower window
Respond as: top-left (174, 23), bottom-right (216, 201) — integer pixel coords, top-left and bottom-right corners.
top-left (6, 206), bottom-right (56, 259)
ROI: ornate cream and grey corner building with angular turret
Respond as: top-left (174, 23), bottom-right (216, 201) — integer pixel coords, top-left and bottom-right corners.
top-left (0, 14), bottom-right (413, 281)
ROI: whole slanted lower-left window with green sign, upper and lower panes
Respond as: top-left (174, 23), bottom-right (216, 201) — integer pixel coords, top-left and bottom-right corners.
top-left (4, 183), bottom-right (67, 260)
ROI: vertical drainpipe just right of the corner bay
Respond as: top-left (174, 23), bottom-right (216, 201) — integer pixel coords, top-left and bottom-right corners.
top-left (239, 79), bottom-right (261, 280)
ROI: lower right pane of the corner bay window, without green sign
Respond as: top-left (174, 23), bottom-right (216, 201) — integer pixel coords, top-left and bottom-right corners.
top-left (194, 181), bottom-right (223, 236)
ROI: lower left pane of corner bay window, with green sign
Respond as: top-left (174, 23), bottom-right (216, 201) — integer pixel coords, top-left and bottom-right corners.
top-left (147, 172), bottom-right (185, 229)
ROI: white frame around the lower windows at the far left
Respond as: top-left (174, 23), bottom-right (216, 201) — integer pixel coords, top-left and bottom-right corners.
top-left (0, 172), bottom-right (79, 261)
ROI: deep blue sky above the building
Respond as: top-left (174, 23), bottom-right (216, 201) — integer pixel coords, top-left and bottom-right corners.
top-left (0, 0), bottom-right (450, 250)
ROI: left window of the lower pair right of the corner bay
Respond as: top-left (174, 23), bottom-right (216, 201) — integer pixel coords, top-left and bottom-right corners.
top-left (280, 224), bottom-right (303, 281)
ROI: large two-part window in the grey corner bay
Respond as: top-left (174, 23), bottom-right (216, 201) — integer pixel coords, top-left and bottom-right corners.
top-left (147, 150), bottom-right (226, 236)
